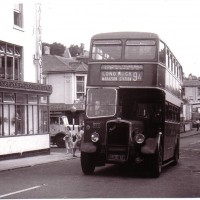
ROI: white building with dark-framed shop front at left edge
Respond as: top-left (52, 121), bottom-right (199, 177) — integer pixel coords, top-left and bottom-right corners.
top-left (0, 1), bottom-right (52, 159)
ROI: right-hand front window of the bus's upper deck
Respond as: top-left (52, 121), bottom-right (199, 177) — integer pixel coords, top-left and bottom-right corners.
top-left (125, 40), bottom-right (156, 60)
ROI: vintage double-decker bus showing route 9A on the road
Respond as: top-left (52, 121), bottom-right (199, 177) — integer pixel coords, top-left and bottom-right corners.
top-left (81, 32), bottom-right (183, 177)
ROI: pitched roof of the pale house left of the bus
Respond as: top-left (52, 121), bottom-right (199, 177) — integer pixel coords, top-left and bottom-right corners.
top-left (42, 55), bottom-right (88, 73)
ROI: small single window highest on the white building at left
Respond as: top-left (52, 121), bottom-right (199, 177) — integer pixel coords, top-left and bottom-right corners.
top-left (14, 3), bottom-right (23, 28)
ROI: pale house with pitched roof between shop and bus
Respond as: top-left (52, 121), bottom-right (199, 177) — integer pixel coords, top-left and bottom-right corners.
top-left (42, 52), bottom-right (88, 125)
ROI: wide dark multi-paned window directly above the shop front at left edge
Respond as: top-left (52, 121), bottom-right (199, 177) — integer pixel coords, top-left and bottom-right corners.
top-left (0, 42), bottom-right (22, 80)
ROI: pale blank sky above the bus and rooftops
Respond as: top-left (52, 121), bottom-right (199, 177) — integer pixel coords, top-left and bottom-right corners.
top-left (41, 0), bottom-right (200, 77)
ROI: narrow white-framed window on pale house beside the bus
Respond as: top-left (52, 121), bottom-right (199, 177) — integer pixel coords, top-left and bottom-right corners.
top-left (76, 76), bottom-right (86, 100)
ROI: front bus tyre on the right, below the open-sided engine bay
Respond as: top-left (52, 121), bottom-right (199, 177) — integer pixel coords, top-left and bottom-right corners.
top-left (149, 146), bottom-right (163, 178)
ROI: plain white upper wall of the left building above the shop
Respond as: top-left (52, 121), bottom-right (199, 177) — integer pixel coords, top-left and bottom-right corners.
top-left (0, 1), bottom-right (37, 82)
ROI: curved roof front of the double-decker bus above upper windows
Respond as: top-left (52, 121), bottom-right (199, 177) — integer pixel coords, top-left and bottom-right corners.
top-left (92, 32), bottom-right (159, 40)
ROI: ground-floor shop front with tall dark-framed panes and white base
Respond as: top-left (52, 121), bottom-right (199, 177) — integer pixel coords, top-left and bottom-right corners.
top-left (0, 80), bottom-right (52, 160)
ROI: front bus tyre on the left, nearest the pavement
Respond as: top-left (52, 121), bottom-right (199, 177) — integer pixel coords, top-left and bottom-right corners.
top-left (81, 152), bottom-right (95, 175)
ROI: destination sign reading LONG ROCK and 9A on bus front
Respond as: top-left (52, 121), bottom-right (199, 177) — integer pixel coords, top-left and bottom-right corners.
top-left (101, 71), bottom-right (143, 82)
